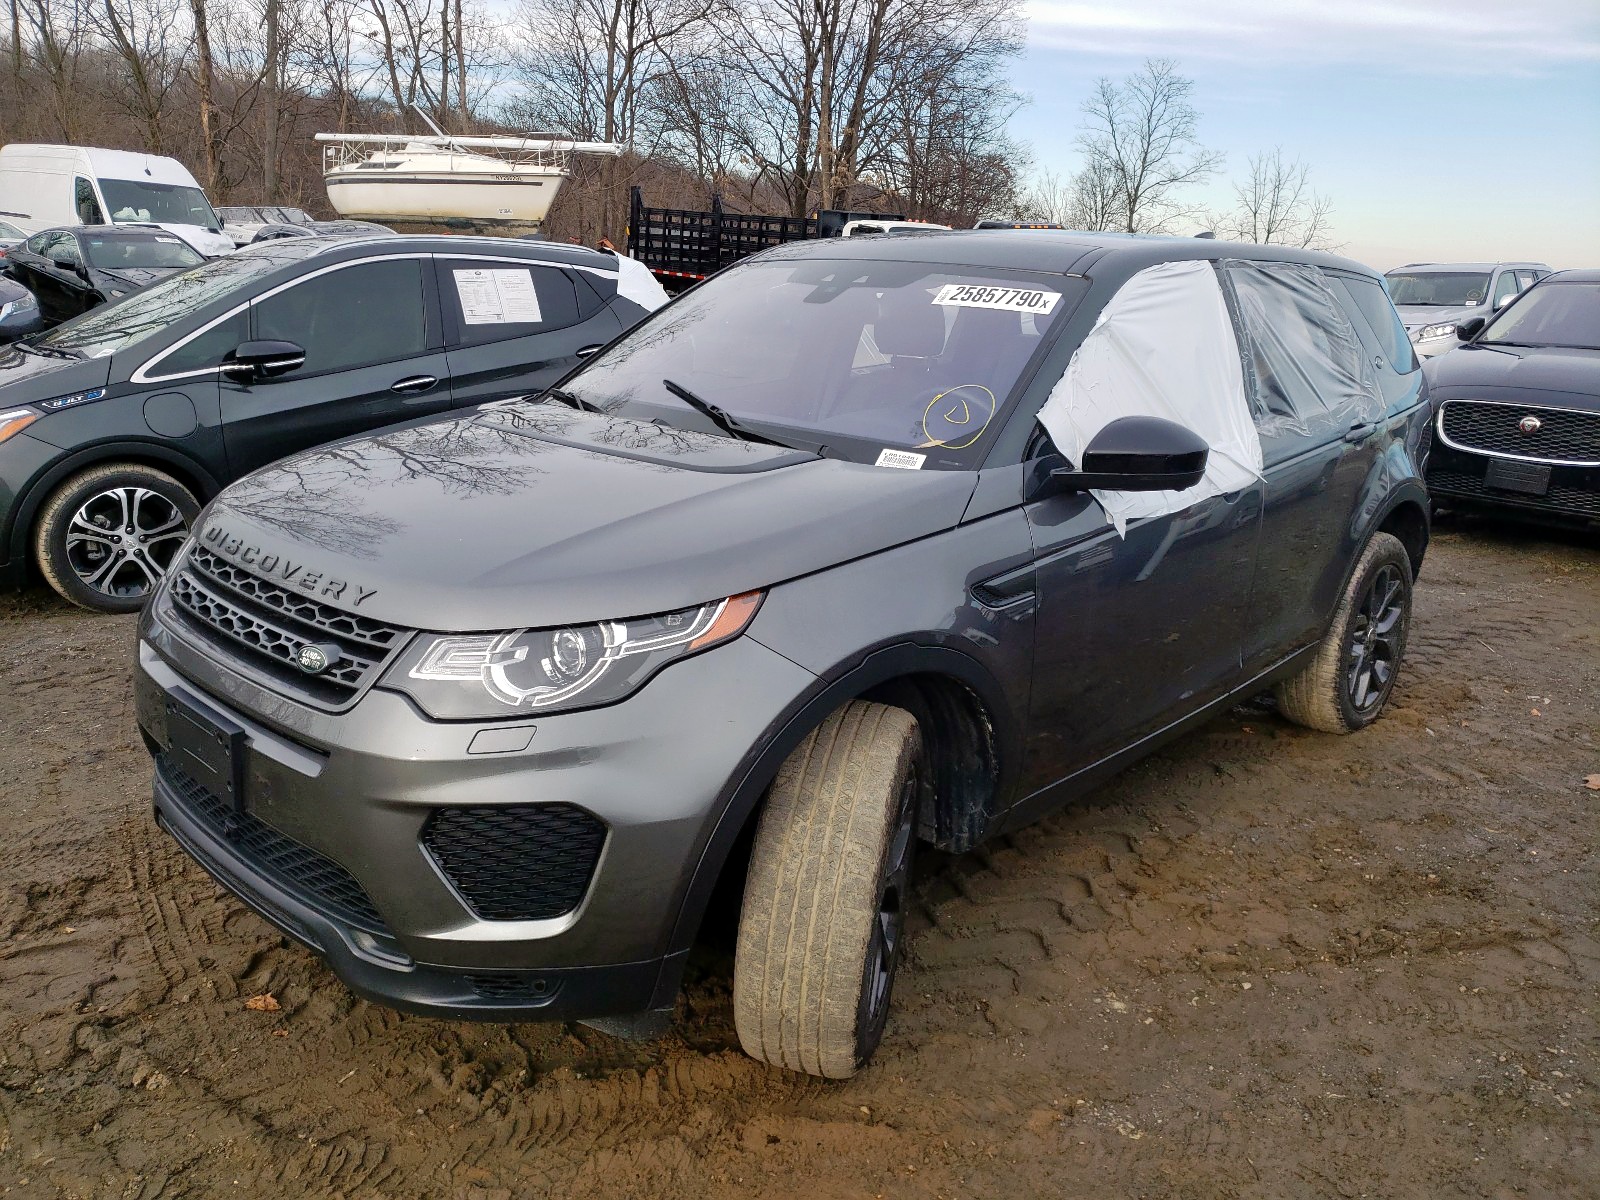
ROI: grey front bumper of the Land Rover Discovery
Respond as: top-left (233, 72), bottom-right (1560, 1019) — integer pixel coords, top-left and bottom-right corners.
top-left (134, 592), bottom-right (814, 1019)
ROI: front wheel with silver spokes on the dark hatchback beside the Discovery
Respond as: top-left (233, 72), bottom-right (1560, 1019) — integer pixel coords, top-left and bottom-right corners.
top-left (34, 462), bottom-right (200, 613)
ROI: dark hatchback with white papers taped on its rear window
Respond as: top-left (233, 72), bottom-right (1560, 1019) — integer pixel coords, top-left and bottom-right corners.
top-left (0, 235), bottom-right (666, 611)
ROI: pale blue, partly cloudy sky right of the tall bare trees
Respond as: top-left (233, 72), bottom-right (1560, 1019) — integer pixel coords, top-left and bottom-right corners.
top-left (1011, 0), bottom-right (1600, 270)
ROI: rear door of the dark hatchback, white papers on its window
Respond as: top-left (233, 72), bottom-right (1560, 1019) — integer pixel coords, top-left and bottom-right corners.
top-left (435, 254), bottom-right (622, 408)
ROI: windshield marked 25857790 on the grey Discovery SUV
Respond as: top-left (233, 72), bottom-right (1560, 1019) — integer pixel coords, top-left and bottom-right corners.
top-left (565, 259), bottom-right (1086, 470)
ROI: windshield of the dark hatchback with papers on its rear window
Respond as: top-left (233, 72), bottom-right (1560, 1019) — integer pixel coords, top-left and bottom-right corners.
top-left (35, 238), bottom-right (310, 358)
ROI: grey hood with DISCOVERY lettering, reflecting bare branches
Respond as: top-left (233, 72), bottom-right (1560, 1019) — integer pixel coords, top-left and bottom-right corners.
top-left (195, 402), bottom-right (976, 632)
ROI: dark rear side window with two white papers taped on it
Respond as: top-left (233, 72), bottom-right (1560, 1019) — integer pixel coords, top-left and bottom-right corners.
top-left (440, 259), bottom-right (581, 346)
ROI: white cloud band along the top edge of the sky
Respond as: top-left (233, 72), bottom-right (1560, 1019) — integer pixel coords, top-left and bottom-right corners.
top-left (1026, 0), bottom-right (1600, 77)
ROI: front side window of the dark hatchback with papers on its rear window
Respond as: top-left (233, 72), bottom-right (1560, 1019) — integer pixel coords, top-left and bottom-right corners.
top-left (254, 258), bottom-right (427, 379)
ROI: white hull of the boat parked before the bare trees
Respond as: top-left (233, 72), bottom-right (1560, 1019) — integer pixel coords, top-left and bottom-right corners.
top-left (323, 168), bottom-right (565, 234)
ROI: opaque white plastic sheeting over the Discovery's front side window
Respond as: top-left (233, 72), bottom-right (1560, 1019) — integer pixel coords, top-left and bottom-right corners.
top-left (1038, 261), bottom-right (1261, 533)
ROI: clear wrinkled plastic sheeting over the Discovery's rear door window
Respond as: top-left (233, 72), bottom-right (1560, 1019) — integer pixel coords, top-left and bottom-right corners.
top-left (1222, 259), bottom-right (1387, 442)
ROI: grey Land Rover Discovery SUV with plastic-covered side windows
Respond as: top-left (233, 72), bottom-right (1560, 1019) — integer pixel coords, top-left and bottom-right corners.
top-left (134, 230), bottom-right (1429, 1077)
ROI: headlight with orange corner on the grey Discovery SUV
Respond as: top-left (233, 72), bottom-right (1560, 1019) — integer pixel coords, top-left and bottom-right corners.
top-left (382, 592), bottom-right (762, 720)
